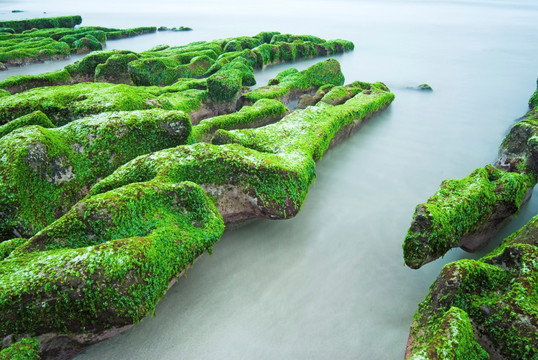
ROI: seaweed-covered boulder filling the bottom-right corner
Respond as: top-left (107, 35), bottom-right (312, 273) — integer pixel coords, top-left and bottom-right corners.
top-left (406, 217), bottom-right (538, 360)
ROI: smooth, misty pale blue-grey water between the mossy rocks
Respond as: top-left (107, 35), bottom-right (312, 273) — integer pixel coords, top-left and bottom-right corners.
top-left (0, 0), bottom-right (538, 360)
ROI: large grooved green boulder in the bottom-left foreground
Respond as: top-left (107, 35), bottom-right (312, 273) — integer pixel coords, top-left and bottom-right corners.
top-left (0, 182), bottom-right (224, 359)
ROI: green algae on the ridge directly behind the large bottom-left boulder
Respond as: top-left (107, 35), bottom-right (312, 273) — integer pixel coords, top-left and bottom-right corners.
top-left (90, 143), bottom-right (315, 219)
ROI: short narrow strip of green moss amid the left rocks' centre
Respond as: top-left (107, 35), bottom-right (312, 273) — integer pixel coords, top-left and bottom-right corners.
top-left (192, 99), bottom-right (287, 142)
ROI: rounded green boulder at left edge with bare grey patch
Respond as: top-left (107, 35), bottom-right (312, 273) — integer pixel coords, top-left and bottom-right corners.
top-left (0, 110), bottom-right (192, 240)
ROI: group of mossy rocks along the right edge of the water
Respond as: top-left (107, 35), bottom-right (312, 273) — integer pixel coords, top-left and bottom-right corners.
top-left (403, 83), bottom-right (538, 360)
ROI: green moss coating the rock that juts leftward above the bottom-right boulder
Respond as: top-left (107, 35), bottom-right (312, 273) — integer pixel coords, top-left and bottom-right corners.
top-left (403, 165), bottom-right (534, 268)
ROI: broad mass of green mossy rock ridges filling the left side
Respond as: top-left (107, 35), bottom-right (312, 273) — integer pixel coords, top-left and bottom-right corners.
top-left (0, 23), bottom-right (394, 359)
